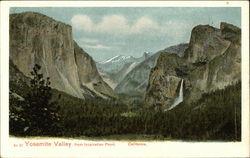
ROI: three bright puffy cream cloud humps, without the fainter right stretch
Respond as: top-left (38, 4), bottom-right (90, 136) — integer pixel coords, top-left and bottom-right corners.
top-left (71, 14), bottom-right (164, 34)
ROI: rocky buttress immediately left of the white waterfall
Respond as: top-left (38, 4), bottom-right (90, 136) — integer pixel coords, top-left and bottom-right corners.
top-left (145, 53), bottom-right (186, 108)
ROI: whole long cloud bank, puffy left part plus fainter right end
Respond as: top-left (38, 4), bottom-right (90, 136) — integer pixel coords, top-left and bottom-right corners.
top-left (71, 14), bottom-right (194, 43)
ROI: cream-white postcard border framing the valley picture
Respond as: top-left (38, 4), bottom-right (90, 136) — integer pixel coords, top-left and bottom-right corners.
top-left (0, 1), bottom-right (250, 157)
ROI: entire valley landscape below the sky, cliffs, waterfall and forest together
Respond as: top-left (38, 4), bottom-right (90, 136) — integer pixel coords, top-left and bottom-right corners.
top-left (9, 12), bottom-right (241, 141)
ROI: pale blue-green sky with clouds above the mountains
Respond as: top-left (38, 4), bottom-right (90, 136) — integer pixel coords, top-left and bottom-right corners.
top-left (10, 7), bottom-right (241, 61)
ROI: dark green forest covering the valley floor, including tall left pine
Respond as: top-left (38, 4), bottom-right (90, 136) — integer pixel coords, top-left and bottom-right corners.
top-left (9, 65), bottom-right (241, 141)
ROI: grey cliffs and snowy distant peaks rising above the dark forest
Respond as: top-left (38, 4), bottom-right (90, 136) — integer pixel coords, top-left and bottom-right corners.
top-left (10, 12), bottom-right (241, 110)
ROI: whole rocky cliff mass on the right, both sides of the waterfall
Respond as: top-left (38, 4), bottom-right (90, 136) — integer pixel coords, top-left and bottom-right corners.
top-left (145, 23), bottom-right (241, 109)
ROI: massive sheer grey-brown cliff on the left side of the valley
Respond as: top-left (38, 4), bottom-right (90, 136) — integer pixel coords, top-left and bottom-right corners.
top-left (10, 12), bottom-right (115, 98)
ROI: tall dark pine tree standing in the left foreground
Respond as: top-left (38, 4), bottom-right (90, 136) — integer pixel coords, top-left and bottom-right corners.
top-left (24, 64), bottom-right (60, 136)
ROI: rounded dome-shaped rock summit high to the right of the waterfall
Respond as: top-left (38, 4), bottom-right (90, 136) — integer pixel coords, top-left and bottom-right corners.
top-left (185, 25), bottom-right (230, 63)
